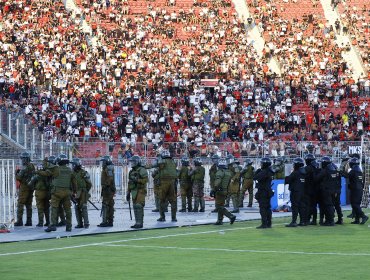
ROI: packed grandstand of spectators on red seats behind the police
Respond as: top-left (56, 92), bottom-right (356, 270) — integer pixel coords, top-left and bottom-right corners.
top-left (0, 0), bottom-right (370, 157)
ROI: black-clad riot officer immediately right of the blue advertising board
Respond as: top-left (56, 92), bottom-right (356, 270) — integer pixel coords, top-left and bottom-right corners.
top-left (285, 158), bottom-right (307, 227)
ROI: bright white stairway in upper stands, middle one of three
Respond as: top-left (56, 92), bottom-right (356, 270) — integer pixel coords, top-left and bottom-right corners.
top-left (232, 0), bottom-right (281, 76)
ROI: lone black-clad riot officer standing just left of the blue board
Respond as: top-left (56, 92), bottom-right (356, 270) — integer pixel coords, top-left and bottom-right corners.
top-left (253, 157), bottom-right (274, 229)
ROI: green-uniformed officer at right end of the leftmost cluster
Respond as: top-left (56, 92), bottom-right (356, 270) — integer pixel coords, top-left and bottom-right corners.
top-left (72, 158), bottom-right (92, 228)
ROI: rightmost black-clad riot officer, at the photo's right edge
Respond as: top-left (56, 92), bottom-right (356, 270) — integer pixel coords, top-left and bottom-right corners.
top-left (345, 157), bottom-right (369, 225)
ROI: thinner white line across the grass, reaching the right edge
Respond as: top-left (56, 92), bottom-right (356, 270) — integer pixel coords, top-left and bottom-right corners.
top-left (104, 244), bottom-right (370, 257)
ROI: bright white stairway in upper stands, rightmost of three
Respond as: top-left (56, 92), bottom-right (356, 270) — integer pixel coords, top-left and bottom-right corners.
top-left (320, 0), bottom-right (367, 81)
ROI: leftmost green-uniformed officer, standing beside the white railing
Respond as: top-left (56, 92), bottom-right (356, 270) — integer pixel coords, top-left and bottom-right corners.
top-left (14, 153), bottom-right (35, 226)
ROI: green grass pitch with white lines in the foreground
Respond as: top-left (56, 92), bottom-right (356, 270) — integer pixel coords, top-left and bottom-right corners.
top-left (0, 214), bottom-right (370, 280)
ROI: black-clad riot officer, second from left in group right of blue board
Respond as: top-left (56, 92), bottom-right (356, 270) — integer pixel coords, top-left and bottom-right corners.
top-left (304, 154), bottom-right (320, 225)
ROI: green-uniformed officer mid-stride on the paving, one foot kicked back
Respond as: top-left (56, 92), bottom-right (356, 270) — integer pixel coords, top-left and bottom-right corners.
top-left (210, 158), bottom-right (236, 225)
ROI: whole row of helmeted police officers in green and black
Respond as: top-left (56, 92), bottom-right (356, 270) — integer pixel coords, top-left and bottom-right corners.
top-left (15, 150), bottom-right (368, 232)
